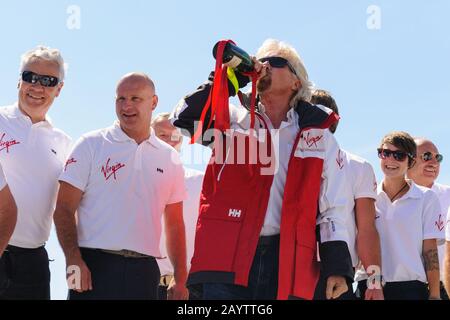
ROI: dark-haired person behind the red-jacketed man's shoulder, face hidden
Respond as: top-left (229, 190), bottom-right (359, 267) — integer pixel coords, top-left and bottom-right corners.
top-left (311, 89), bottom-right (383, 300)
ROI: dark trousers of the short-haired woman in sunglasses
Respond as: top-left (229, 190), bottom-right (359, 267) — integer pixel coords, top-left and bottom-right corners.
top-left (358, 280), bottom-right (428, 300)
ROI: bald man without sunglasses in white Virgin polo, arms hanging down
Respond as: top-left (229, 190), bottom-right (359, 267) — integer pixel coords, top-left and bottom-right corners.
top-left (54, 73), bottom-right (188, 300)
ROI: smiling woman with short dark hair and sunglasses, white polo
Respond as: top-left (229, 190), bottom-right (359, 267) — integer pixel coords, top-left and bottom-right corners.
top-left (360, 132), bottom-right (443, 300)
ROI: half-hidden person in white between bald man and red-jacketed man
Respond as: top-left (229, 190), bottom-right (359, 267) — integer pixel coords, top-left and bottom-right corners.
top-left (152, 112), bottom-right (205, 300)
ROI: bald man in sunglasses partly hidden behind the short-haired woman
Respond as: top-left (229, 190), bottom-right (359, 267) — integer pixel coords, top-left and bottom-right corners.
top-left (407, 138), bottom-right (450, 300)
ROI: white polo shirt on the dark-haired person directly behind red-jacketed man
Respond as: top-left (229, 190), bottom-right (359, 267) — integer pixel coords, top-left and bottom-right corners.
top-left (337, 150), bottom-right (377, 267)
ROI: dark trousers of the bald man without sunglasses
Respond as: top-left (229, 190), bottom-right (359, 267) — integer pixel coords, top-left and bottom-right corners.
top-left (69, 248), bottom-right (160, 300)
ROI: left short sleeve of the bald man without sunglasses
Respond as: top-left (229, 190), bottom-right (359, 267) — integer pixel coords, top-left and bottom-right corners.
top-left (59, 137), bottom-right (92, 192)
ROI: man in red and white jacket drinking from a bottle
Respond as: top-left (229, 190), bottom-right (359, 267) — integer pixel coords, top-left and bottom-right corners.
top-left (172, 39), bottom-right (353, 300)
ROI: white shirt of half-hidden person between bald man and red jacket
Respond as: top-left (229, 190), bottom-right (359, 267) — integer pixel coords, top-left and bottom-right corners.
top-left (157, 167), bottom-right (205, 275)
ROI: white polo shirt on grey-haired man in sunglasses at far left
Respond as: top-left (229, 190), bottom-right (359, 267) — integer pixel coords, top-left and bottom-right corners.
top-left (0, 104), bottom-right (71, 248)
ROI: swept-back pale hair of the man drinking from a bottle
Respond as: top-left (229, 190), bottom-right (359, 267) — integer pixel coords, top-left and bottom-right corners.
top-left (256, 39), bottom-right (314, 107)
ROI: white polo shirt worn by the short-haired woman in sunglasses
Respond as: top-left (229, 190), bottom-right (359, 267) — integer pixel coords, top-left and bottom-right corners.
top-left (375, 181), bottom-right (444, 283)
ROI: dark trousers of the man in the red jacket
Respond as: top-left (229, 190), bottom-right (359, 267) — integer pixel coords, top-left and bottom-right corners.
top-left (203, 236), bottom-right (280, 300)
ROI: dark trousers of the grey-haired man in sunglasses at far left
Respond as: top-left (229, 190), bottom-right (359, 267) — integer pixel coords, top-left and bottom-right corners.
top-left (0, 246), bottom-right (50, 300)
